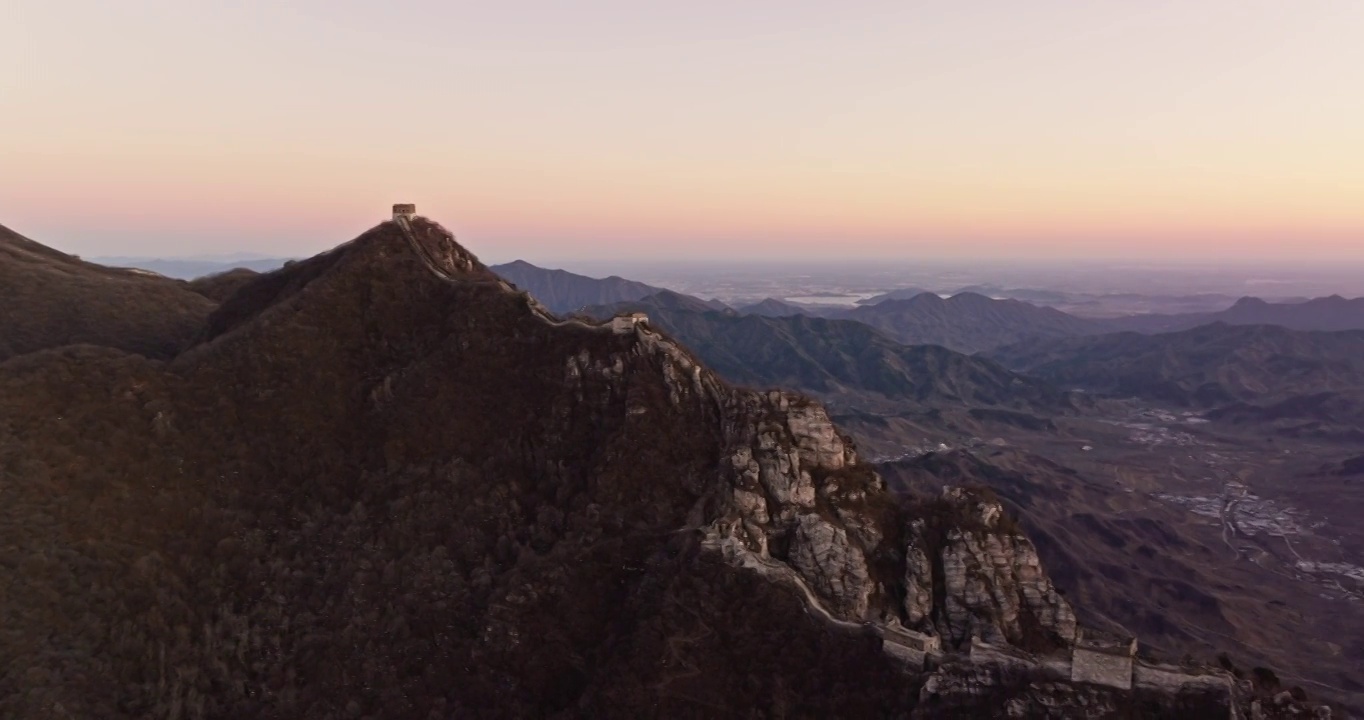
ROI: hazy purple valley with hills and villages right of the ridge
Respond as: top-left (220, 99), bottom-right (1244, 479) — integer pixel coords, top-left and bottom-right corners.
top-left (548, 257), bottom-right (1364, 706)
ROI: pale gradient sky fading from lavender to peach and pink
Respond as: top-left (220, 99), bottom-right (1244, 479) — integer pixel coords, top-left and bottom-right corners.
top-left (0, 0), bottom-right (1364, 260)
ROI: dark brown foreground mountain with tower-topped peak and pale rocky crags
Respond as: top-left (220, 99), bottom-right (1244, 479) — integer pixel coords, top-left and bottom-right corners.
top-left (0, 220), bottom-right (1320, 717)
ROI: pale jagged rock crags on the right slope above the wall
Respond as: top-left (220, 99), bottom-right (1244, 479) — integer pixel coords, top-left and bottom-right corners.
top-left (687, 345), bottom-right (1075, 649)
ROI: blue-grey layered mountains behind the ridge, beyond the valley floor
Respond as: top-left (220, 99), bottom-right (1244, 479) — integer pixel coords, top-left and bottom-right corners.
top-left (494, 262), bottom-right (1364, 415)
